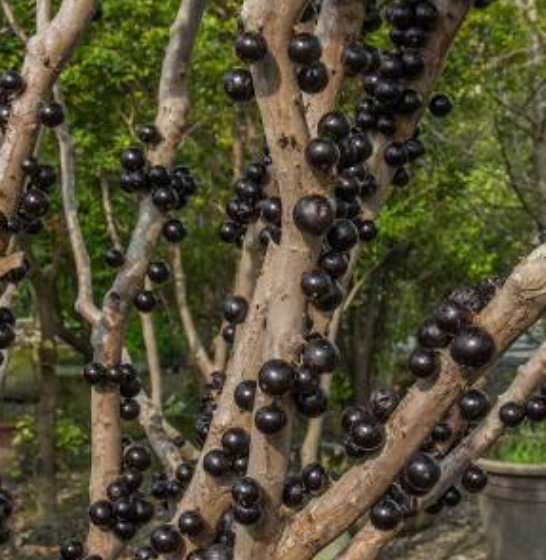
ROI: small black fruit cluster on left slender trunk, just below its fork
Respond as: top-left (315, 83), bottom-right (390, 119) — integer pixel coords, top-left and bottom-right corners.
top-left (83, 362), bottom-right (142, 421)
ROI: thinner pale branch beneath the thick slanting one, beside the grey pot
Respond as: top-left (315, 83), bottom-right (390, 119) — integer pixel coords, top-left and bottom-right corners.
top-left (336, 336), bottom-right (546, 560)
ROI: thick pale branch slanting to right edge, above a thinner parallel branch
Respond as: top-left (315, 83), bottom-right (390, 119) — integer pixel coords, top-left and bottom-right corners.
top-left (278, 237), bottom-right (546, 560)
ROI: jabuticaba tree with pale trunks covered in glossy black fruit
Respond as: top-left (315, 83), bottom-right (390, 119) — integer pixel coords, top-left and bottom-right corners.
top-left (0, 0), bottom-right (546, 560)
